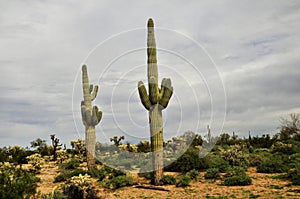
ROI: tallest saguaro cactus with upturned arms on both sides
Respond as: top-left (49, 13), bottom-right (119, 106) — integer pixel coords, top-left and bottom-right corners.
top-left (138, 18), bottom-right (173, 185)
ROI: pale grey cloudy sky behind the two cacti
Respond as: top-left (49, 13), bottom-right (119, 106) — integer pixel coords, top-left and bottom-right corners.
top-left (0, 0), bottom-right (300, 146)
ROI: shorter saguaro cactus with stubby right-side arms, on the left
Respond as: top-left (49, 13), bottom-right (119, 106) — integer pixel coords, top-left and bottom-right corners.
top-left (81, 65), bottom-right (102, 170)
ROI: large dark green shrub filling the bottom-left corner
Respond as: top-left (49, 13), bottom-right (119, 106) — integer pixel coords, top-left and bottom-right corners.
top-left (0, 164), bottom-right (40, 199)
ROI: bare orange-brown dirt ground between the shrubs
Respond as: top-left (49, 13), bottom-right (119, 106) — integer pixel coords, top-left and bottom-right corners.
top-left (38, 163), bottom-right (300, 199)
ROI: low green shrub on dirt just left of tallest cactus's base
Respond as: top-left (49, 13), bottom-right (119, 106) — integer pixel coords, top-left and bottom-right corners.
top-left (104, 175), bottom-right (134, 189)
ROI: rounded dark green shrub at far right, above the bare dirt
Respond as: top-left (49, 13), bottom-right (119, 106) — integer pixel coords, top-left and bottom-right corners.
top-left (257, 156), bottom-right (288, 173)
